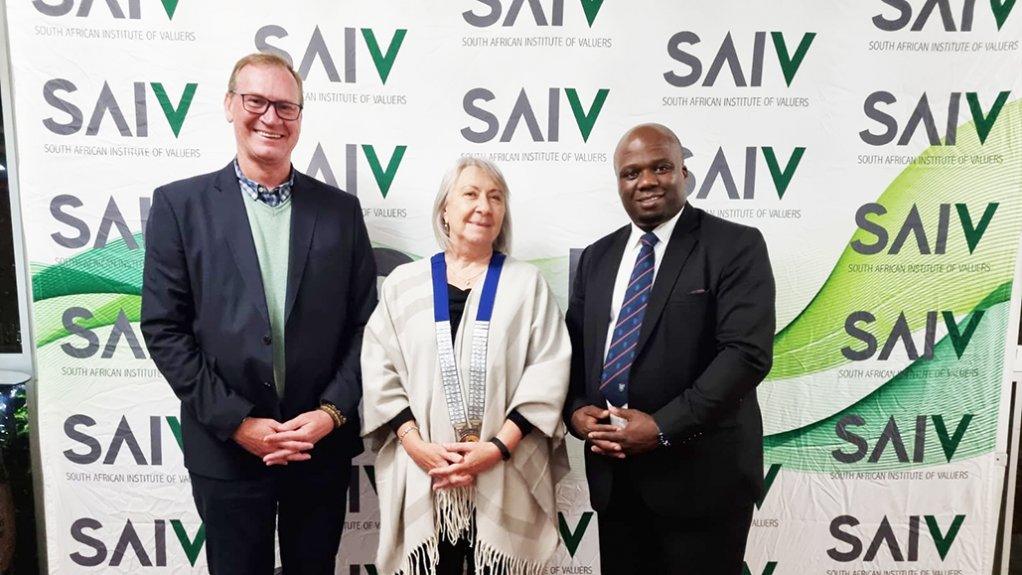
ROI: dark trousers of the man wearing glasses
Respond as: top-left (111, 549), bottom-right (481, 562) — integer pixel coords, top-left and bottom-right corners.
top-left (190, 465), bottom-right (352, 575)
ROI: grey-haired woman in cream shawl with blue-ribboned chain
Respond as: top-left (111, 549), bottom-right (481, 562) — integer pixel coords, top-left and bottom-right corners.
top-left (362, 158), bottom-right (571, 575)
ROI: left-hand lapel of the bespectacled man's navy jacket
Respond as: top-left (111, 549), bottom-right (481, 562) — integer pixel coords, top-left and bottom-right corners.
top-left (213, 163), bottom-right (270, 325)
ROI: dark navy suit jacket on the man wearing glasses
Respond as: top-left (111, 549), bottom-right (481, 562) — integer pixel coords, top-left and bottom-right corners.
top-left (141, 163), bottom-right (376, 479)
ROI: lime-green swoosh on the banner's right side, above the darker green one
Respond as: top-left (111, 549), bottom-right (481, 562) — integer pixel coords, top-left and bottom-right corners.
top-left (768, 100), bottom-right (1022, 380)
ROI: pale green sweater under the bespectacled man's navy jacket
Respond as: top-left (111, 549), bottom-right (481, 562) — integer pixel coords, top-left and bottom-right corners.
top-left (244, 195), bottom-right (291, 397)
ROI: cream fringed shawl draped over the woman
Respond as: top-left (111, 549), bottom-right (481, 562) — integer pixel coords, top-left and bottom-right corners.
top-left (362, 257), bottom-right (571, 575)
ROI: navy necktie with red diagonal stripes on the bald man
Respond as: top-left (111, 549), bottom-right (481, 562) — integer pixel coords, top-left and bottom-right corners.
top-left (600, 232), bottom-right (657, 406)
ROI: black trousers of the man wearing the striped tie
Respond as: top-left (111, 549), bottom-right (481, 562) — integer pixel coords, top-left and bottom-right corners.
top-left (597, 466), bottom-right (752, 575)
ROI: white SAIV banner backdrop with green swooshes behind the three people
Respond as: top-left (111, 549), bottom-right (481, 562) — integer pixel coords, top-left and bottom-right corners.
top-left (6, 0), bottom-right (1022, 575)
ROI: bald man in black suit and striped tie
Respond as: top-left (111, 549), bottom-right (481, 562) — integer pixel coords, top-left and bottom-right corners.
top-left (565, 125), bottom-right (775, 575)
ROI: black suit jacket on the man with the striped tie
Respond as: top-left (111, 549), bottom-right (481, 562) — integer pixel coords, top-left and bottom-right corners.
top-left (565, 205), bottom-right (775, 516)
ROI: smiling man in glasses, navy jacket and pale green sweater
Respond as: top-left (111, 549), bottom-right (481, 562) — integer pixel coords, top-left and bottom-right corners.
top-left (142, 54), bottom-right (376, 575)
